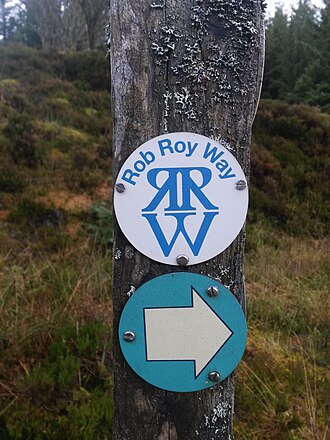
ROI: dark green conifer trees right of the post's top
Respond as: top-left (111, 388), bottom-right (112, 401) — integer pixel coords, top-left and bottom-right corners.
top-left (263, 0), bottom-right (330, 112)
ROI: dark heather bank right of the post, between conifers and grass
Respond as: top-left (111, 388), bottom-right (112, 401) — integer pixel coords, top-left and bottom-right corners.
top-left (249, 101), bottom-right (330, 237)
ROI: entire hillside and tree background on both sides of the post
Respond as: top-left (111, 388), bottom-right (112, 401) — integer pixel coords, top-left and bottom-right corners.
top-left (0, 0), bottom-right (330, 440)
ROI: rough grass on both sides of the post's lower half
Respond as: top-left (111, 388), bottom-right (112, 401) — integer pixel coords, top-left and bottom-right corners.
top-left (0, 223), bottom-right (330, 440)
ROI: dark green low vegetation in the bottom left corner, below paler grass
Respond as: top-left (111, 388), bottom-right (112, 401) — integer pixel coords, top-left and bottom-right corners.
top-left (2, 322), bottom-right (112, 440)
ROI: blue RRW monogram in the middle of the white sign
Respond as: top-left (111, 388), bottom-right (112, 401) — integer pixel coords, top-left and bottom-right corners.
top-left (142, 167), bottom-right (219, 257)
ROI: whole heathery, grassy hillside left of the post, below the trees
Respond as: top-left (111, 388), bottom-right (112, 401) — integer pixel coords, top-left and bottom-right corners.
top-left (0, 45), bottom-right (112, 440)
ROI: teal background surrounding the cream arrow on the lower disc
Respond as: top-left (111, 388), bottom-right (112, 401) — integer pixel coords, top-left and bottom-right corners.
top-left (119, 272), bottom-right (247, 392)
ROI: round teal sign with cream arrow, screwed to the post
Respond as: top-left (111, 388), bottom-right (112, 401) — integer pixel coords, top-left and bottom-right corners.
top-left (119, 272), bottom-right (247, 392)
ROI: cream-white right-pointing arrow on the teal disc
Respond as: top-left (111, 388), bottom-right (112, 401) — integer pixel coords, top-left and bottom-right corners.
top-left (144, 287), bottom-right (233, 377)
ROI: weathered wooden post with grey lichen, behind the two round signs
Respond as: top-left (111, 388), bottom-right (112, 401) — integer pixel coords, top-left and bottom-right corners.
top-left (110, 0), bottom-right (264, 440)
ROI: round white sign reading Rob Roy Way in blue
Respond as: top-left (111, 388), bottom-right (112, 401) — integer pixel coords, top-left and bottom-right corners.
top-left (114, 133), bottom-right (248, 265)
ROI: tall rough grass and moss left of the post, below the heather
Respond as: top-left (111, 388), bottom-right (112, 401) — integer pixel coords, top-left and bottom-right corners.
top-left (0, 238), bottom-right (112, 440)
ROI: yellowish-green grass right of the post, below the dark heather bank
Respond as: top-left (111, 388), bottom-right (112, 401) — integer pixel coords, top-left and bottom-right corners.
top-left (234, 225), bottom-right (330, 440)
